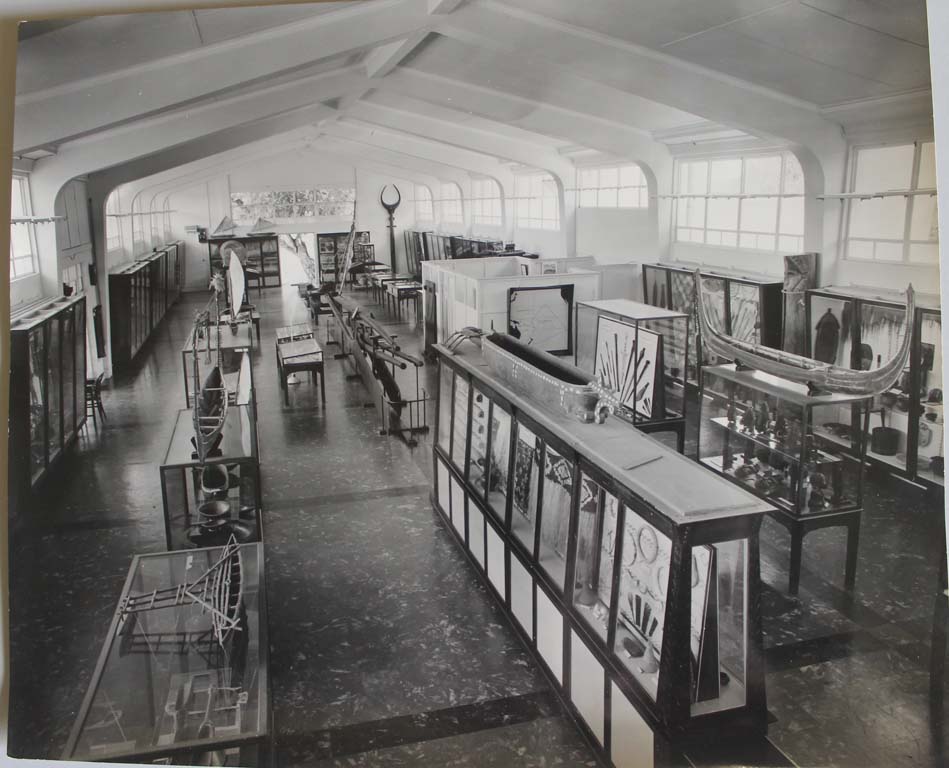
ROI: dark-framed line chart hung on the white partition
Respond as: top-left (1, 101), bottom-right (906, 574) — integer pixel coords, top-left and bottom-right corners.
top-left (507, 284), bottom-right (573, 355)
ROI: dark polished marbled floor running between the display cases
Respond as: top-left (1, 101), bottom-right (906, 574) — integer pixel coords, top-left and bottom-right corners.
top-left (9, 260), bottom-right (949, 768)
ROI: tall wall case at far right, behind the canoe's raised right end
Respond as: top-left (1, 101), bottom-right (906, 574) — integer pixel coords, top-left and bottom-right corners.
top-left (806, 286), bottom-right (944, 489)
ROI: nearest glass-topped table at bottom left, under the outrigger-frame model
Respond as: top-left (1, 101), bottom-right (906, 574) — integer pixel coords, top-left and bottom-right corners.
top-left (62, 543), bottom-right (271, 766)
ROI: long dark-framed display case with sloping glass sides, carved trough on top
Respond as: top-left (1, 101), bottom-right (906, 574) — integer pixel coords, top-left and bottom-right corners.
top-left (432, 336), bottom-right (770, 765)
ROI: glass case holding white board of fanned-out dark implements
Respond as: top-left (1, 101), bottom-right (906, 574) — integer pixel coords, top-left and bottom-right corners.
top-left (575, 299), bottom-right (690, 453)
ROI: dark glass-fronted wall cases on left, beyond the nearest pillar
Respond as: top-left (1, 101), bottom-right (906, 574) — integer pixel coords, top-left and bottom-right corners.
top-left (109, 243), bottom-right (184, 369)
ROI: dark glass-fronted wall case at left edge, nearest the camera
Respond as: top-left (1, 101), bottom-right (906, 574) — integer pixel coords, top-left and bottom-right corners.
top-left (8, 296), bottom-right (86, 514)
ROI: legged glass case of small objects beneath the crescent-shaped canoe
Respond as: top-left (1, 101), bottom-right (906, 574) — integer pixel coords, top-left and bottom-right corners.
top-left (698, 364), bottom-right (879, 594)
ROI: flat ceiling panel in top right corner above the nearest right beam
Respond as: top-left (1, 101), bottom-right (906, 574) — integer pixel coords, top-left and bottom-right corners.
top-left (506, 0), bottom-right (929, 106)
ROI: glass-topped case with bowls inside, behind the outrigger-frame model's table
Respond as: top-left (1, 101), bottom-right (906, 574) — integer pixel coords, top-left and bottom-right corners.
top-left (159, 405), bottom-right (263, 550)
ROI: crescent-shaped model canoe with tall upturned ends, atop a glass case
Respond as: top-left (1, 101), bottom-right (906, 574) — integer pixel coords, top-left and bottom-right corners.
top-left (695, 270), bottom-right (916, 397)
